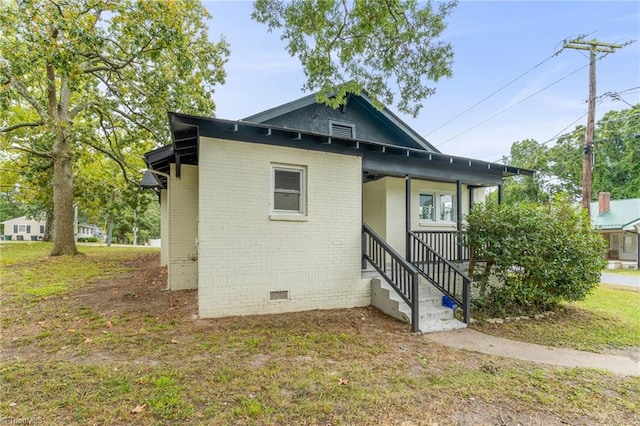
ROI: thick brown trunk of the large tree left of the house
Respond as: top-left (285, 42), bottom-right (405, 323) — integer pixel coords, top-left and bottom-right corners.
top-left (51, 133), bottom-right (78, 256)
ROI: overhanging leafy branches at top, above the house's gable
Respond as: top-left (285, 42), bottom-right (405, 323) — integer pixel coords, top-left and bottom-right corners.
top-left (252, 0), bottom-right (457, 117)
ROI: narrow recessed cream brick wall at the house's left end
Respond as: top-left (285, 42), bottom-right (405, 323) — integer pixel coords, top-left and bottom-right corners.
top-left (167, 164), bottom-right (198, 290)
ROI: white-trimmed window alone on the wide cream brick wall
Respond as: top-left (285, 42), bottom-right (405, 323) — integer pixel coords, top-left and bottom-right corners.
top-left (271, 164), bottom-right (306, 215)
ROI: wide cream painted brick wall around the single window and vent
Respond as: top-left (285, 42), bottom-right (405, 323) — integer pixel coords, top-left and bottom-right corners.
top-left (198, 138), bottom-right (371, 317)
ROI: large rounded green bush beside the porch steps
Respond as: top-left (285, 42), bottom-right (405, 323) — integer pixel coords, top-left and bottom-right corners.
top-left (467, 196), bottom-right (606, 315)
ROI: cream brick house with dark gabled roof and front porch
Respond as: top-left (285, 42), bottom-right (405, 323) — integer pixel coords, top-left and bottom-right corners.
top-left (143, 95), bottom-right (533, 331)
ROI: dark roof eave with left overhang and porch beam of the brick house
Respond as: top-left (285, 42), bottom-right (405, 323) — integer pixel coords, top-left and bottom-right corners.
top-left (144, 112), bottom-right (534, 187)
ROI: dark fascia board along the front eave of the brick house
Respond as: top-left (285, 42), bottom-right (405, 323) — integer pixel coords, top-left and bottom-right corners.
top-left (170, 113), bottom-right (534, 177)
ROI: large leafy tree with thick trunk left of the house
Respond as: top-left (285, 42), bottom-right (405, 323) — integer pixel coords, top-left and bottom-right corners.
top-left (0, 0), bottom-right (228, 255)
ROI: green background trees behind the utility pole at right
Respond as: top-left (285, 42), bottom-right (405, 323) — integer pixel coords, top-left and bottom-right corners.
top-left (503, 104), bottom-right (640, 203)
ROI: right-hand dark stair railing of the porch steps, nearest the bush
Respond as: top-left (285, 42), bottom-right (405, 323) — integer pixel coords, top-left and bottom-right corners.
top-left (407, 231), bottom-right (471, 324)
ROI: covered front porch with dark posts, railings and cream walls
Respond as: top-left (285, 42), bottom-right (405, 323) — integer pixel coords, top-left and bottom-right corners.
top-left (362, 148), bottom-right (533, 331)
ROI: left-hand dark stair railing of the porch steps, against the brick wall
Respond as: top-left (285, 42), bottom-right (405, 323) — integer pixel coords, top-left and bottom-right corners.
top-left (362, 224), bottom-right (420, 332)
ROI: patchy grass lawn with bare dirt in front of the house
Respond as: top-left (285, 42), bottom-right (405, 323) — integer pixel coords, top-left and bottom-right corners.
top-left (0, 243), bottom-right (640, 425)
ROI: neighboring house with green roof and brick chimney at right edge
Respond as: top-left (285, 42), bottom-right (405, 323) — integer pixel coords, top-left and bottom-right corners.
top-left (591, 192), bottom-right (640, 269)
